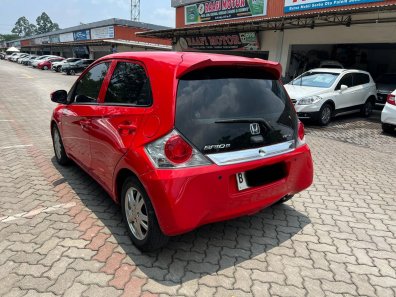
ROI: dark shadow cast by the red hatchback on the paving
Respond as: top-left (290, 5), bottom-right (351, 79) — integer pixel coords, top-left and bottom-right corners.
top-left (52, 158), bottom-right (310, 286)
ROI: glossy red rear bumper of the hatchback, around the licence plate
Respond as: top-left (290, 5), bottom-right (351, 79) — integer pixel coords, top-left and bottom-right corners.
top-left (140, 145), bottom-right (313, 235)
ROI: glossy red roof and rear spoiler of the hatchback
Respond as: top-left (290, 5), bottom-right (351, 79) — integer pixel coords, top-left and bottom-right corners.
top-left (97, 51), bottom-right (281, 78)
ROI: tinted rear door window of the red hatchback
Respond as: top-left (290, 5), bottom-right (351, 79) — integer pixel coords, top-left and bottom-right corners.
top-left (105, 62), bottom-right (152, 106)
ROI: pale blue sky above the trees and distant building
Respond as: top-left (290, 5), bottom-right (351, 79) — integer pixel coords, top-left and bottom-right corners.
top-left (0, 0), bottom-right (175, 34)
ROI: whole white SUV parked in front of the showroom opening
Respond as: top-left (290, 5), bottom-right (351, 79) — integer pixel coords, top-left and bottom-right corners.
top-left (285, 68), bottom-right (377, 126)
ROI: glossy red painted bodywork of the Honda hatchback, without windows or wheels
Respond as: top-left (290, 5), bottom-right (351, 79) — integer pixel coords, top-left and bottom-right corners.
top-left (53, 52), bottom-right (313, 235)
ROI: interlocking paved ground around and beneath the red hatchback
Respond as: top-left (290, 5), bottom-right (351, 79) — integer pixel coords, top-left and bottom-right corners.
top-left (0, 61), bottom-right (396, 297)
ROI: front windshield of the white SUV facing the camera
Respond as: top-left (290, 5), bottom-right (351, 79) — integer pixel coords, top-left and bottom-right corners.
top-left (290, 72), bottom-right (340, 88)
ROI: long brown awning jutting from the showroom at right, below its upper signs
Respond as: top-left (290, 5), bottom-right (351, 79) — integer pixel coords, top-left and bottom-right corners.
top-left (136, 3), bottom-right (396, 41)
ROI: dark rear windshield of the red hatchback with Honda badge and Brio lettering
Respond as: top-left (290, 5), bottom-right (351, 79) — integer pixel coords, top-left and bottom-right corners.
top-left (176, 67), bottom-right (297, 154)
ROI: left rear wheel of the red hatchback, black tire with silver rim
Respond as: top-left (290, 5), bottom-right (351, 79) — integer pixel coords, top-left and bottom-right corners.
top-left (121, 177), bottom-right (169, 252)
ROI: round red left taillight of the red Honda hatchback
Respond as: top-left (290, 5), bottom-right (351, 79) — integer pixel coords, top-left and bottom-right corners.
top-left (164, 135), bottom-right (193, 164)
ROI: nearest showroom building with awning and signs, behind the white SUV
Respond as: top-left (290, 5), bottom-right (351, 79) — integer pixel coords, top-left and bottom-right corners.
top-left (138, 0), bottom-right (396, 80)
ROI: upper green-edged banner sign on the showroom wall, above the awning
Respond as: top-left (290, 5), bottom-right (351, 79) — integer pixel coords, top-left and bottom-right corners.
top-left (184, 0), bottom-right (267, 25)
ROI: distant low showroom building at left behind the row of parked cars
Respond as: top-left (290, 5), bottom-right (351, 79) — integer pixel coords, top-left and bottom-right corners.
top-left (0, 19), bottom-right (172, 59)
